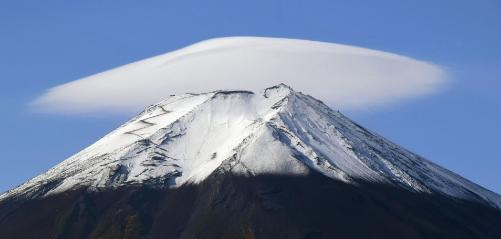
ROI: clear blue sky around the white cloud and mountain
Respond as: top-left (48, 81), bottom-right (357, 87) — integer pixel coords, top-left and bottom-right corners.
top-left (0, 0), bottom-right (501, 193)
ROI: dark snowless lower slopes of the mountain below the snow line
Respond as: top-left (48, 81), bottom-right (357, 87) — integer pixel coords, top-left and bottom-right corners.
top-left (0, 174), bottom-right (501, 239)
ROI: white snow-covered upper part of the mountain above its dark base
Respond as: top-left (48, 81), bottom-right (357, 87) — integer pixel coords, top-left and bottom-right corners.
top-left (0, 85), bottom-right (501, 208)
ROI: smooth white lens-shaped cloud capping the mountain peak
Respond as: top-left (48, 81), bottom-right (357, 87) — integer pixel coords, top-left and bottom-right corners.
top-left (33, 37), bottom-right (446, 113)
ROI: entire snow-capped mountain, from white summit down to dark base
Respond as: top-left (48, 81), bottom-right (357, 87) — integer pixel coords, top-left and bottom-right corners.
top-left (0, 84), bottom-right (501, 238)
